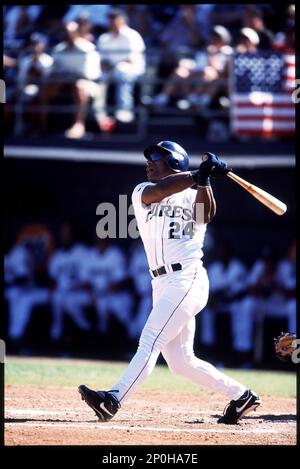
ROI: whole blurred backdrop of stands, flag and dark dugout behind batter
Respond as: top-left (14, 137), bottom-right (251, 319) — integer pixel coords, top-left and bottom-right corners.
top-left (1, 4), bottom-right (296, 369)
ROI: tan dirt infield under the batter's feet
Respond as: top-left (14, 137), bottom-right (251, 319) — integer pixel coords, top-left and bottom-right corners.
top-left (5, 386), bottom-right (296, 446)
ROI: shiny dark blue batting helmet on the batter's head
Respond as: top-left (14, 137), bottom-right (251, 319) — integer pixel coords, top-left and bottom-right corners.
top-left (144, 140), bottom-right (189, 173)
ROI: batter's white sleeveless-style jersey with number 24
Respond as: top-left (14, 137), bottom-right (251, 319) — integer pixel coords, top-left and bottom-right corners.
top-left (132, 182), bottom-right (207, 270)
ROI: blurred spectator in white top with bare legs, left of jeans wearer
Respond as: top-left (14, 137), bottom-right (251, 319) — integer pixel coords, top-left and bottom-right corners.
top-left (41, 22), bottom-right (101, 139)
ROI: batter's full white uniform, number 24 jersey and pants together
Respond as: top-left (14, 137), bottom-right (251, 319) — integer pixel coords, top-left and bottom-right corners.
top-left (112, 182), bottom-right (246, 404)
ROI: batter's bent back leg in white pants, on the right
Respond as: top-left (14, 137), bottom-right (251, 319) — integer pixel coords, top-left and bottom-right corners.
top-left (162, 313), bottom-right (246, 399)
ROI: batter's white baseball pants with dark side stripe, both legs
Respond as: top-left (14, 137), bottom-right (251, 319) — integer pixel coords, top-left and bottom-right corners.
top-left (111, 261), bottom-right (246, 403)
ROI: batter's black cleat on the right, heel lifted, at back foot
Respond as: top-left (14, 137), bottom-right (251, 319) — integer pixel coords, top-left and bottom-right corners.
top-left (218, 389), bottom-right (261, 425)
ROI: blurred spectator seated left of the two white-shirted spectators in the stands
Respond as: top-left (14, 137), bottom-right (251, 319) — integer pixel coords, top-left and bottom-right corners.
top-left (18, 33), bottom-right (53, 135)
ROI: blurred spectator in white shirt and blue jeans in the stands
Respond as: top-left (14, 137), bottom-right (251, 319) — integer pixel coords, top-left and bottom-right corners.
top-left (98, 9), bottom-right (145, 124)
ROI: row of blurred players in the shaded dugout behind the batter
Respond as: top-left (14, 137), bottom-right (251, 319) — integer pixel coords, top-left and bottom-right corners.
top-left (4, 222), bottom-right (296, 363)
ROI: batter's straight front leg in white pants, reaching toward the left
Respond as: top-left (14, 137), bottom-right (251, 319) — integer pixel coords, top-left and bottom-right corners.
top-left (112, 265), bottom-right (208, 403)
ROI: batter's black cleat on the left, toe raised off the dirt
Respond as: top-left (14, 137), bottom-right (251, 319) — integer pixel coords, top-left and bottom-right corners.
top-left (78, 384), bottom-right (121, 422)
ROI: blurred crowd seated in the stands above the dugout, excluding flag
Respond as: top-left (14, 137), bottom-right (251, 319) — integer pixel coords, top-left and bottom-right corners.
top-left (3, 4), bottom-right (295, 139)
